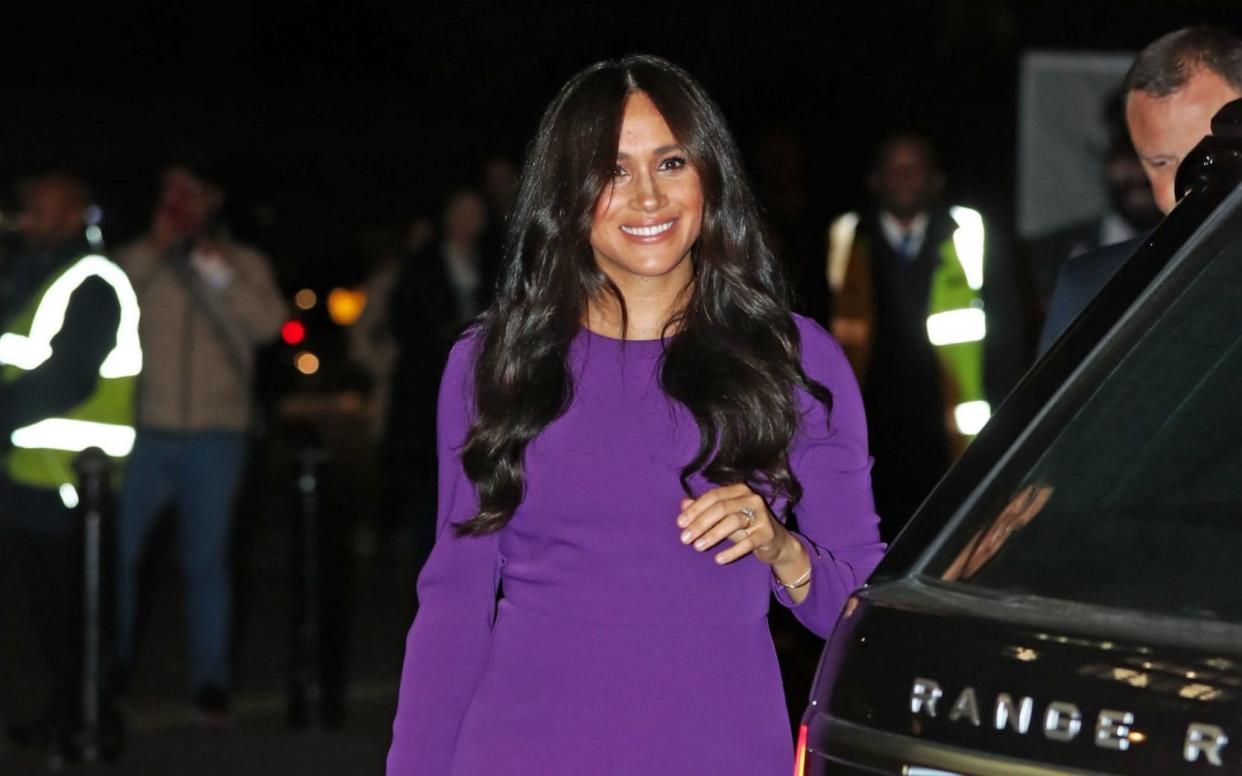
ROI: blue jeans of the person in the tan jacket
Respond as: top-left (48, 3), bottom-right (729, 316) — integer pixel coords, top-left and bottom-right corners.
top-left (117, 430), bottom-right (246, 689)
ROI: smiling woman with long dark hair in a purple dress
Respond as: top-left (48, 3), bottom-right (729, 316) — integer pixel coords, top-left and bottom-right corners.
top-left (389, 56), bottom-right (883, 776)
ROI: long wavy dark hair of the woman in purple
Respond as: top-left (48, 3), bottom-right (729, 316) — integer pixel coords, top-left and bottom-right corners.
top-left (456, 56), bottom-right (832, 535)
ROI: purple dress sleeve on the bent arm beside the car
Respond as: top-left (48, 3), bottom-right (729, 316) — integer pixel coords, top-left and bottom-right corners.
top-left (773, 318), bottom-right (884, 637)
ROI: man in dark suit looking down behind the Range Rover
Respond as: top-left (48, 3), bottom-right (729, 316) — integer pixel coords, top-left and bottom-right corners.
top-left (1040, 26), bottom-right (1242, 354)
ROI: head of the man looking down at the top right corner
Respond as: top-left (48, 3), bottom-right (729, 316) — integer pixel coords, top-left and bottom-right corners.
top-left (1125, 26), bottom-right (1242, 212)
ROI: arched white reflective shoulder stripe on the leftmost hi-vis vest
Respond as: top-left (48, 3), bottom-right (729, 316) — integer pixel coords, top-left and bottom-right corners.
top-left (0, 255), bottom-right (143, 377)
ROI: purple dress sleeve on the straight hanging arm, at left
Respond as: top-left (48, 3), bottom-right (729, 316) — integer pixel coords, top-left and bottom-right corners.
top-left (388, 336), bottom-right (499, 776)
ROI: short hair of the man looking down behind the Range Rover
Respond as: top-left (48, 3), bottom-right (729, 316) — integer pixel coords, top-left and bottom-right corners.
top-left (1125, 25), bottom-right (1242, 97)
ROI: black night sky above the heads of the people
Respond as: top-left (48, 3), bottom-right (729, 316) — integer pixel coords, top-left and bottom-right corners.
top-left (0, 0), bottom-right (1242, 288)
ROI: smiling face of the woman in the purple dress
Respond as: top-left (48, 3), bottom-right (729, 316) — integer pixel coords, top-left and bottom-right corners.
top-left (591, 92), bottom-right (703, 291)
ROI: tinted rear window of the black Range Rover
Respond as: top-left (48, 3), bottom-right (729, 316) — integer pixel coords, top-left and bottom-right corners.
top-left (925, 229), bottom-right (1242, 622)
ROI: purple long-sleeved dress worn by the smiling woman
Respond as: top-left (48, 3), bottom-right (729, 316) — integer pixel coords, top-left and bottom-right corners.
top-left (388, 311), bottom-right (883, 776)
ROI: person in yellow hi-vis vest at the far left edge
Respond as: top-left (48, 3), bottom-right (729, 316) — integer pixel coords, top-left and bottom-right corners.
top-left (0, 173), bottom-right (143, 757)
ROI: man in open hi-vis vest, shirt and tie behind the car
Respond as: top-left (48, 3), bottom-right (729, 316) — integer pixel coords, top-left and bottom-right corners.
top-left (826, 134), bottom-right (1026, 540)
